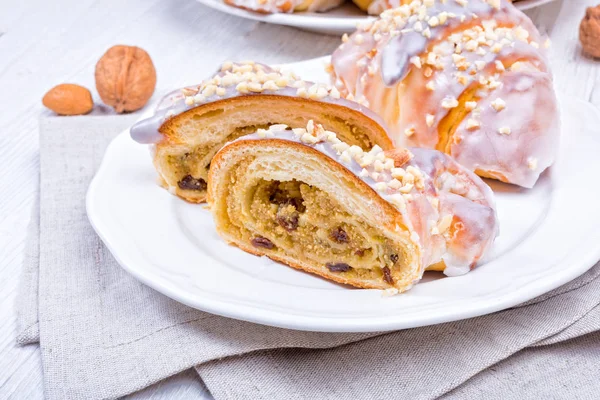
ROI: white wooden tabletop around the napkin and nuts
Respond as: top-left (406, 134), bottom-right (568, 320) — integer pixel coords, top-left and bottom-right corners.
top-left (0, 0), bottom-right (600, 399)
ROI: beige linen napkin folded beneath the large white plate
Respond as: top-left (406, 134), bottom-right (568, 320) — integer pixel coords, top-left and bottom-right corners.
top-left (12, 115), bottom-right (600, 400)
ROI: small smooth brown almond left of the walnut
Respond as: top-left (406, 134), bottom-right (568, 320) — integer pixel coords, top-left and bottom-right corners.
top-left (42, 83), bottom-right (94, 115)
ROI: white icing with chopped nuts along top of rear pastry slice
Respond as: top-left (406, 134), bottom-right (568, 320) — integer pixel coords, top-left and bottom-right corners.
top-left (131, 61), bottom-right (385, 148)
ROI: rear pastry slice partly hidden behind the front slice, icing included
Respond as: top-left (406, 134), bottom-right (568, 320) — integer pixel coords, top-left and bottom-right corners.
top-left (131, 62), bottom-right (393, 202)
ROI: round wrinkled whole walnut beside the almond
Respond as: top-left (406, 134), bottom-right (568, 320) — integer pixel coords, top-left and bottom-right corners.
top-left (95, 45), bottom-right (156, 113)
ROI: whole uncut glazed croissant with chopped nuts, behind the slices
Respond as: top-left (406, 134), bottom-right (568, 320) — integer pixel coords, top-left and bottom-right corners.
top-left (330, 0), bottom-right (560, 187)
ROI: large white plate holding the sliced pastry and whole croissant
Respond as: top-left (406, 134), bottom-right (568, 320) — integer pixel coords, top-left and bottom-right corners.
top-left (87, 59), bottom-right (600, 332)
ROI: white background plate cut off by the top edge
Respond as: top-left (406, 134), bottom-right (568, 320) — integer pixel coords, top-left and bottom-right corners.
top-left (198, 0), bottom-right (554, 35)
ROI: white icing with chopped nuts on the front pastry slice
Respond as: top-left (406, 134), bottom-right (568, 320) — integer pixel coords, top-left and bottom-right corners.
top-left (232, 121), bottom-right (497, 275)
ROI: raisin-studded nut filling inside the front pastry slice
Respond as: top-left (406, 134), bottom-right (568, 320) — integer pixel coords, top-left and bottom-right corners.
top-left (230, 177), bottom-right (405, 285)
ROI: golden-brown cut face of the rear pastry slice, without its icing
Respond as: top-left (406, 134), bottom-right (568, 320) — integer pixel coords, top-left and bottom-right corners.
top-left (154, 94), bottom-right (393, 203)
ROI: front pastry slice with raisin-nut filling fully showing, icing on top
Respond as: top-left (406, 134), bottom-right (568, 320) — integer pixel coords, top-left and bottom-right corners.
top-left (208, 121), bottom-right (497, 292)
